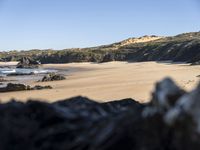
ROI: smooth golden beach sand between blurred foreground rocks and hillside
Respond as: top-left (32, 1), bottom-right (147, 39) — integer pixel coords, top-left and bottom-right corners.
top-left (0, 62), bottom-right (200, 102)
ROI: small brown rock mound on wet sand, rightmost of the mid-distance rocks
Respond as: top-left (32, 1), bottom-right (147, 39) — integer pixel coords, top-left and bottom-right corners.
top-left (41, 73), bottom-right (66, 82)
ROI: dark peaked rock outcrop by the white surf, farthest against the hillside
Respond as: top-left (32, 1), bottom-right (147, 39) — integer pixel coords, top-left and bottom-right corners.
top-left (17, 57), bottom-right (41, 69)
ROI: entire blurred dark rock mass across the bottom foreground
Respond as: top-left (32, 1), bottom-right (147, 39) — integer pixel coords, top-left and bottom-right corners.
top-left (0, 79), bottom-right (200, 150)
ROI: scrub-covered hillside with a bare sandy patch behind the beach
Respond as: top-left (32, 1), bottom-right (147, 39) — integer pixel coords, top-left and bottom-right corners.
top-left (0, 32), bottom-right (200, 63)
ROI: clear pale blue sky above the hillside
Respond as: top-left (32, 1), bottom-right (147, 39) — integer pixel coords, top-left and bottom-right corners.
top-left (0, 0), bottom-right (200, 51)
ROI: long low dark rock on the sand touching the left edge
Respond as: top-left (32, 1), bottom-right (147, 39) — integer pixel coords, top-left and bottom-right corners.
top-left (0, 83), bottom-right (52, 92)
